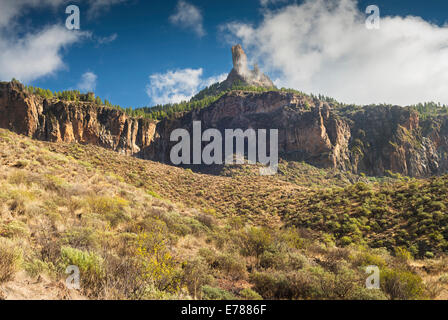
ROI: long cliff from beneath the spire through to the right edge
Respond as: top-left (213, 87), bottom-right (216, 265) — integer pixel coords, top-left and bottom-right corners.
top-left (141, 91), bottom-right (448, 177)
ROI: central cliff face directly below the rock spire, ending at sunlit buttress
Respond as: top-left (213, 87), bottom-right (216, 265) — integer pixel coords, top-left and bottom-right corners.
top-left (142, 91), bottom-right (351, 170)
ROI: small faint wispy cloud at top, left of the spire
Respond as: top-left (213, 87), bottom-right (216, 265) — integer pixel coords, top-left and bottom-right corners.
top-left (170, 0), bottom-right (205, 37)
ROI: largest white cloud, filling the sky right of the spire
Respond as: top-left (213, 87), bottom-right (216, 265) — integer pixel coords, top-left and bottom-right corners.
top-left (228, 0), bottom-right (448, 105)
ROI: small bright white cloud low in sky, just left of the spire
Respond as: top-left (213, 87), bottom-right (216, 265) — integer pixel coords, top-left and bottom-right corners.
top-left (146, 68), bottom-right (226, 104)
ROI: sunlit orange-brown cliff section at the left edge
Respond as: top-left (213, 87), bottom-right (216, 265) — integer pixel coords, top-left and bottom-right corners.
top-left (0, 82), bottom-right (156, 155)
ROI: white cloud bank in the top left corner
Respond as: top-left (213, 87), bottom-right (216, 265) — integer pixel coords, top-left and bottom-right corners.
top-left (0, 0), bottom-right (127, 82)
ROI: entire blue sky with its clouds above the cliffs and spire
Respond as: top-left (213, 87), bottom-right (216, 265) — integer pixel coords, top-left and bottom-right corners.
top-left (4, 0), bottom-right (448, 107)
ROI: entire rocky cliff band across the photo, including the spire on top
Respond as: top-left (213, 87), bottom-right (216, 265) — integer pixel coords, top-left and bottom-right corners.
top-left (0, 46), bottom-right (448, 177)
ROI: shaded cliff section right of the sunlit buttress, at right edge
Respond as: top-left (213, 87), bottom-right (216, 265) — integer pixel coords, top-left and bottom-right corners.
top-left (348, 106), bottom-right (448, 177)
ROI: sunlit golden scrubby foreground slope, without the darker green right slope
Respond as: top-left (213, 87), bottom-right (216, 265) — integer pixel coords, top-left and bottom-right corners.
top-left (0, 130), bottom-right (448, 299)
